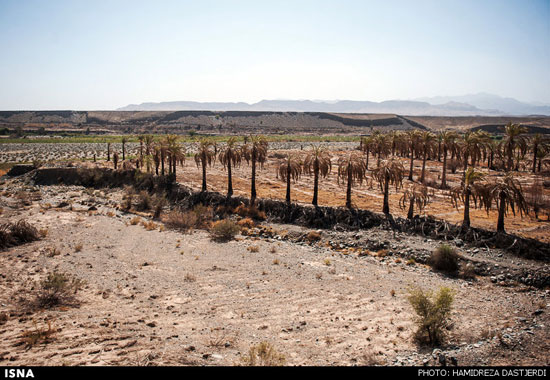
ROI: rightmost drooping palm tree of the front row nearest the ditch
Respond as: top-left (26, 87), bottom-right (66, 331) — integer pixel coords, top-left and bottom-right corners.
top-left (488, 173), bottom-right (529, 233)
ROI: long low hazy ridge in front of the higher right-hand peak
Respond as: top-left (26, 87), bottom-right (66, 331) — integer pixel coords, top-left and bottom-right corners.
top-left (117, 100), bottom-right (512, 116)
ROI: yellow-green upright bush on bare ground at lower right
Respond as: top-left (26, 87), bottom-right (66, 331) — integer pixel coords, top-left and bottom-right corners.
top-left (407, 287), bottom-right (454, 346)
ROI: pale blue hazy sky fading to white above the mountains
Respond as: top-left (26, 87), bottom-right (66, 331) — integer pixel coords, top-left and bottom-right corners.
top-left (0, 0), bottom-right (550, 110)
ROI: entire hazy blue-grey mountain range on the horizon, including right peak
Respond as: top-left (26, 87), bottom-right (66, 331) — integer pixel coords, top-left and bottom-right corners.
top-left (117, 93), bottom-right (550, 116)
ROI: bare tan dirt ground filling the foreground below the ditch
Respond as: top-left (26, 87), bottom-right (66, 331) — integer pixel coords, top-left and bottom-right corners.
top-left (0, 180), bottom-right (550, 366)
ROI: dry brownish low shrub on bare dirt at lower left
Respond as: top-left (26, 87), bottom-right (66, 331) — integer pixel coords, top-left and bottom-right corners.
top-left (35, 272), bottom-right (83, 309)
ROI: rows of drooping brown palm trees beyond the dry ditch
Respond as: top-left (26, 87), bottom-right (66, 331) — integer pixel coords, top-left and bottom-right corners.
top-left (106, 124), bottom-right (550, 231)
